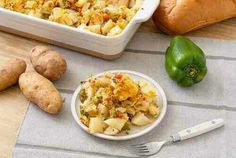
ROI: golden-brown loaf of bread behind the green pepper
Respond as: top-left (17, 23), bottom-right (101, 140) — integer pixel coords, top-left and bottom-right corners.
top-left (153, 0), bottom-right (236, 34)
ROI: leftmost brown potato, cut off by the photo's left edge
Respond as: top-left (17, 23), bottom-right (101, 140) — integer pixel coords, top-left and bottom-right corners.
top-left (0, 58), bottom-right (26, 91)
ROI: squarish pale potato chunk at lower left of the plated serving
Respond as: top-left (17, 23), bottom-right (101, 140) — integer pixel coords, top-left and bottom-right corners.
top-left (89, 117), bottom-right (104, 133)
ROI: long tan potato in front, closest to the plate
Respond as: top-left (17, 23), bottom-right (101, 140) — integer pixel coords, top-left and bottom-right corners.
top-left (19, 72), bottom-right (63, 114)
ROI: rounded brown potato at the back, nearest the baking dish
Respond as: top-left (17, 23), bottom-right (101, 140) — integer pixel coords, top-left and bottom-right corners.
top-left (30, 46), bottom-right (67, 81)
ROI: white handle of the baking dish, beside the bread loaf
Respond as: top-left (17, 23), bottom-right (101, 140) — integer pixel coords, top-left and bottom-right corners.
top-left (134, 0), bottom-right (160, 23)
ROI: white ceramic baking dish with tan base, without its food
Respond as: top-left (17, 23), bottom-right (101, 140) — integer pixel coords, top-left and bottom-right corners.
top-left (0, 0), bottom-right (160, 59)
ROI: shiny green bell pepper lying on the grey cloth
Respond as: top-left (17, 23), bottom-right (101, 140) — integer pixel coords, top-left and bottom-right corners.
top-left (165, 36), bottom-right (207, 87)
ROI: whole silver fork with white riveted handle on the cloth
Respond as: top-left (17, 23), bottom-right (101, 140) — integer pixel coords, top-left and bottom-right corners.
top-left (131, 118), bottom-right (224, 156)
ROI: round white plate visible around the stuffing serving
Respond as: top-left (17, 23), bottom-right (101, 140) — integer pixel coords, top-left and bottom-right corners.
top-left (71, 70), bottom-right (167, 140)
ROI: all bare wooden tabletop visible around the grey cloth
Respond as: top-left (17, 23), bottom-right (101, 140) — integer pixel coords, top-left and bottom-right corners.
top-left (0, 18), bottom-right (236, 158)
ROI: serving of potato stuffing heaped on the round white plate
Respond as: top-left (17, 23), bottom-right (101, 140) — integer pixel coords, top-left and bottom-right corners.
top-left (78, 72), bottom-right (161, 135)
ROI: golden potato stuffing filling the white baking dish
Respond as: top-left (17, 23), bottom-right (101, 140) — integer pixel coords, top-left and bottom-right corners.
top-left (0, 0), bottom-right (143, 36)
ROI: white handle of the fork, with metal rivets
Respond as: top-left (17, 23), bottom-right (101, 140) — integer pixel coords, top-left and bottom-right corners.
top-left (178, 119), bottom-right (224, 140)
